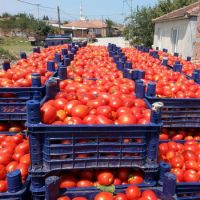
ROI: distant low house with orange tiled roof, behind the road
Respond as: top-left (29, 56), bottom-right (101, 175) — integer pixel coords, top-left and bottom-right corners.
top-left (63, 19), bottom-right (108, 37)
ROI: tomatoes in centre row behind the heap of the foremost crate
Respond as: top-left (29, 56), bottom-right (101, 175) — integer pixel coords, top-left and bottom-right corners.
top-left (67, 46), bottom-right (122, 79)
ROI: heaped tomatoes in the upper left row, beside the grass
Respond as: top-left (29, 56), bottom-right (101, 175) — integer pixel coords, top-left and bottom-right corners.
top-left (0, 45), bottom-right (67, 88)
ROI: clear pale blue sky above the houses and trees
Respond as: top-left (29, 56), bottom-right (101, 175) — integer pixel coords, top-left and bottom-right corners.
top-left (0, 0), bottom-right (157, 23)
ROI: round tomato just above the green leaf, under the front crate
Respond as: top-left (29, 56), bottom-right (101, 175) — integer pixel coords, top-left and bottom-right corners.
top-left (97, 171), bottom-right (114, 186)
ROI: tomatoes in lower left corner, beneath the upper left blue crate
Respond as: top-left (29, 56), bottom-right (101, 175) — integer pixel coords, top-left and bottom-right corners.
top-left (0, 122), bottom-right (30, 192)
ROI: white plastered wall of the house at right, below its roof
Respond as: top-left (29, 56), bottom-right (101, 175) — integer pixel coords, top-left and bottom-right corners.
top-left (153, 17), bottom-right (197, 58)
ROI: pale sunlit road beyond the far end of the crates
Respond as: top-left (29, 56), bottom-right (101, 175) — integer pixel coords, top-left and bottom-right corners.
top-left (92, 37), bottom-right (129, 47)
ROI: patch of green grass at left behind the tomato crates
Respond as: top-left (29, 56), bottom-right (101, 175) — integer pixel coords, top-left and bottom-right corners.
top-left (0, 37), bottom-right (32, 59)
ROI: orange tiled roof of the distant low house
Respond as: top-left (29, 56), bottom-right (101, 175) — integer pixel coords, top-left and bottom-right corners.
top-left (64, 20), bottom-right (107, 28)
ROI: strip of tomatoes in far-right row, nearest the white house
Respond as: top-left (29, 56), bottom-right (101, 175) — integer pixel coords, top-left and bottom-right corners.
top-left (158, 51), bottom-right (200, 76)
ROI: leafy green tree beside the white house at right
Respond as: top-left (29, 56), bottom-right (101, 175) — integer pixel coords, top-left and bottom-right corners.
top-left (124, 0), bottom-right (198, 47)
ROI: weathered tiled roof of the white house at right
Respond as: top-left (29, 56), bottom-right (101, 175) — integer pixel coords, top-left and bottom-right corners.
top-left (153, 1), bottom-right (200, 22)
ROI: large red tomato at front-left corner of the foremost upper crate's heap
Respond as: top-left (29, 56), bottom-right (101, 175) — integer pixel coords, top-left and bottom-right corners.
top-left (41, 105), bottom-right (56, 124)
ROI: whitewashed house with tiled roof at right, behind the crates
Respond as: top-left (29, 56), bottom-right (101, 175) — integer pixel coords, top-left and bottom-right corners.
top-left (153, 2), bottom-right (200, 60)
